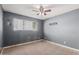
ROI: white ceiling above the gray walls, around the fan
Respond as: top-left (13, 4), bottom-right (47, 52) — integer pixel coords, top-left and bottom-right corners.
top-left (2, 4), bottom-right (79, 19)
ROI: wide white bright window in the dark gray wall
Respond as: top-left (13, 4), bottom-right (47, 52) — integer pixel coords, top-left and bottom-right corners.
top-left (13, 19), bottom-right (38, 31)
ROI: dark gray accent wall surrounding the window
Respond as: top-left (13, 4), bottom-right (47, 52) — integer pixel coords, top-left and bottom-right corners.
top-left (3, 12), bottom-right (43, 46)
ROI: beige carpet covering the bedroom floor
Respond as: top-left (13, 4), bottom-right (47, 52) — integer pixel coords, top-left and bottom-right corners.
top-left (2, 41), bottom-right (79, 55)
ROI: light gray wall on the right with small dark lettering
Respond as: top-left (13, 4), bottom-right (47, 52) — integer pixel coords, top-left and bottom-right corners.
top-left (44, 9), bottom-right (79, 49)
